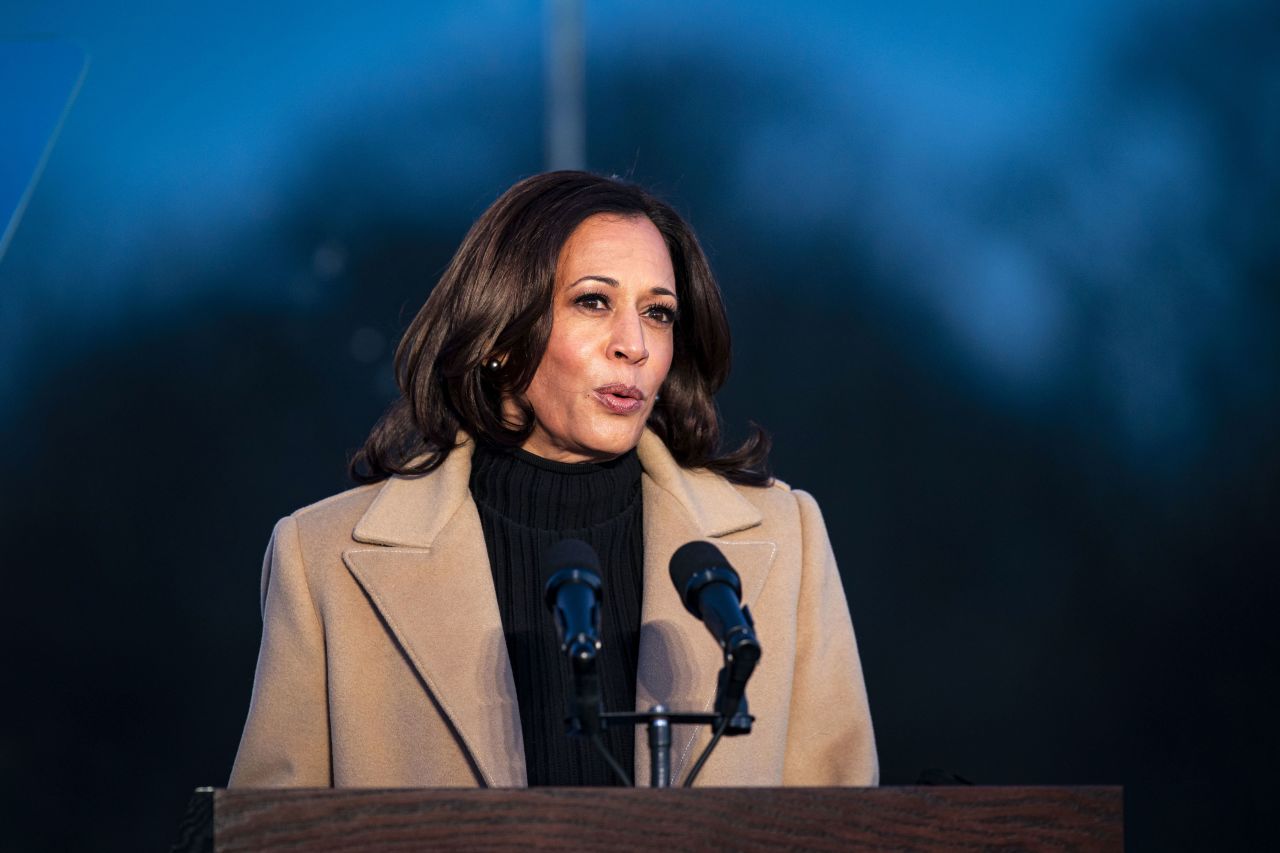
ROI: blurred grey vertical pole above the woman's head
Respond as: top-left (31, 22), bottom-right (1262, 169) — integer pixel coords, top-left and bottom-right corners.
top-left (545, 0), bottom-right (586, 170)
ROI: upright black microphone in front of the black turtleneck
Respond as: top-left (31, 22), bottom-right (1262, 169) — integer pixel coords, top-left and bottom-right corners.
top-left (543, 539), bottom-right (603, 735)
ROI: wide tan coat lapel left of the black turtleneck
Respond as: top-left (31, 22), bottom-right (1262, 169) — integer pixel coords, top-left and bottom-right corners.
top-left (343, 443), bottom-right (526, 788)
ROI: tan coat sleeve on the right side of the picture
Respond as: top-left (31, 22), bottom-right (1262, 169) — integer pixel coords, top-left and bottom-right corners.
top-left (783, 491), bottom-right (879, 785)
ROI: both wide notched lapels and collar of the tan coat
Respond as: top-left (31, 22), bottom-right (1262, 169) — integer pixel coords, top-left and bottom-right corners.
top-left (343, 430), bottom-right (776, 786)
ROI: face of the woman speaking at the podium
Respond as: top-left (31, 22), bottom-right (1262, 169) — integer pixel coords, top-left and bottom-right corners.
top-left (524, 214), bottom-right (677, 462)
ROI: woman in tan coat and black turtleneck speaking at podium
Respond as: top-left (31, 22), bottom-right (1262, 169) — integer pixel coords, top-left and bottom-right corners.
top-left (230, 172), bottom-right (877, 788)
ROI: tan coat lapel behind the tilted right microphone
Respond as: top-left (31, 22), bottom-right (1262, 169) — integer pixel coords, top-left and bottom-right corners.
top-left (635, 432), bottom-right (777, 786)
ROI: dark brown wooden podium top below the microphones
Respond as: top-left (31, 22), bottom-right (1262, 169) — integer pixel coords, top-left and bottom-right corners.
top-left (173, 786), bottom-right (1124, 853)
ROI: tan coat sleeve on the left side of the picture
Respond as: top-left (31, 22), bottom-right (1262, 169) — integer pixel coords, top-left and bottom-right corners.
top-left (229, 517), bottom-right (333, 788)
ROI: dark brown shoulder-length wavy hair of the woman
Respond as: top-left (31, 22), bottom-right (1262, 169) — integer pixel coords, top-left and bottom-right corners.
top-left (349, 172), bottom-right (771, 485)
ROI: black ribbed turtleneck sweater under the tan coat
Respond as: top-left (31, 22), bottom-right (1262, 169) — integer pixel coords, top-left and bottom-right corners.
top-left (471, 444), bottom-right (644, 785)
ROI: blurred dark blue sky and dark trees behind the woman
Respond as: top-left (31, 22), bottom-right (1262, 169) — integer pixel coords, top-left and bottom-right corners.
top-left (0, 0), bottom-right (1280, 850)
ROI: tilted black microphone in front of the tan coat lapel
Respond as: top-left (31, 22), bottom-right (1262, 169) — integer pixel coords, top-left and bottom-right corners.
top-left (671, 542), bottom-right (760, 720)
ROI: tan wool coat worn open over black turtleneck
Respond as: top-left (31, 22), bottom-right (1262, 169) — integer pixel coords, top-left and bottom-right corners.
top-left (230, 432), bottom-right (878, 788)
